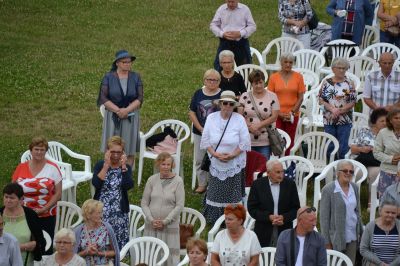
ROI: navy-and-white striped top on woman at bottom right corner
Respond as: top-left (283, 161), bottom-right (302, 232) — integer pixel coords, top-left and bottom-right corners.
top-left (371, 224), bottom-right (399, 264)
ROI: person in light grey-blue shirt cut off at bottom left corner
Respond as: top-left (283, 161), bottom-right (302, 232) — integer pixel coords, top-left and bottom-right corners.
top-left (0, 215), bottom-right (24, 266)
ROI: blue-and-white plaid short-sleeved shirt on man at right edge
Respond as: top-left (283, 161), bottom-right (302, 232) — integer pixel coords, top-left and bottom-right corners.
top-left (363, 70), bottom-right (400, 107)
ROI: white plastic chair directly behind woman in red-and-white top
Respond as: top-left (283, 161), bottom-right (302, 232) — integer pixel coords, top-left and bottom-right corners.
top-left (21, 150), bottom-right (76, 203)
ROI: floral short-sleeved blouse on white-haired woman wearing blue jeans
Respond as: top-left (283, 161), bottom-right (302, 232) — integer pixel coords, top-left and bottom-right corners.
top-left (319, 77), bottom-right (357, 126)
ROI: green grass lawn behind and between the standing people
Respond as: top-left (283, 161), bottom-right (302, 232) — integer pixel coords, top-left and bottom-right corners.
top-left (0, 0), bottom-right (344, 231)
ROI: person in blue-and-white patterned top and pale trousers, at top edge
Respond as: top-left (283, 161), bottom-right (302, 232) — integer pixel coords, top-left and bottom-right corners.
top-left (278, 0), bottom-right (313, 49)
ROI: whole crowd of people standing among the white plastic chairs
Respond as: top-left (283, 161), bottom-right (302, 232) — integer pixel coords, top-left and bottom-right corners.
top-left (0, 0), bottom-right (400, 266)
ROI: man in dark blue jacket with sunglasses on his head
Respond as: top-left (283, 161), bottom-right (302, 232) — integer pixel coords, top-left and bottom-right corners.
top-left (275, 206), bottom-right (327, 266)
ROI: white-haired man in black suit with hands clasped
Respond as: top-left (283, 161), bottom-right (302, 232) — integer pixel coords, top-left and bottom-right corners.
top-left (247, 159), bottom-right (300, 247)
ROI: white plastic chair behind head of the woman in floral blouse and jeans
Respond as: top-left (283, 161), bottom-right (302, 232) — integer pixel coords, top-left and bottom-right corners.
top-left (320, 39), bottom-right (360, 74)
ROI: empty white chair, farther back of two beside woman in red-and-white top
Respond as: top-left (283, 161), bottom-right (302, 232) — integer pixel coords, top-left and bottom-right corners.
top-left (47, 141), bottom-right (94, 197)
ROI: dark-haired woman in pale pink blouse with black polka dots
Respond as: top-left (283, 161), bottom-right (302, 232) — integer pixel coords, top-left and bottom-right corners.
top-left (239, 70), bottom-right (280, 160)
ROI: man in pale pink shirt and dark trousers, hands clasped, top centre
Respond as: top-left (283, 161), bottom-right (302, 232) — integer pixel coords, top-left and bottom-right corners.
top-left (210, 0), bottom-right (256, 71)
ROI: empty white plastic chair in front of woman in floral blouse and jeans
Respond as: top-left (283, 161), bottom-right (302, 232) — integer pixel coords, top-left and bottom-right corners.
top-left (290, 131), bottom-right (339, 173)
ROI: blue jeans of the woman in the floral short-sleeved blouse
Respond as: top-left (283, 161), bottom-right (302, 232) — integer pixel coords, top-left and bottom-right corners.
top-left (324, 124), bottom-right (352, 159)
